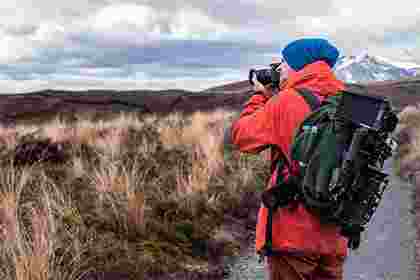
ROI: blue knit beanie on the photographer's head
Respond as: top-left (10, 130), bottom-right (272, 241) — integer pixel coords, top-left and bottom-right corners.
top-left (282, 38), bottom-right (339, 71)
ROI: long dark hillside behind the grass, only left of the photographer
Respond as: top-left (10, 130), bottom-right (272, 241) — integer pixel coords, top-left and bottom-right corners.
top-left (0, 88), bottom-right (249, 125)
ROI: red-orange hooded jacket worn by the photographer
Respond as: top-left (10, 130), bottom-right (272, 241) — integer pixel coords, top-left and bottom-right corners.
top-left (232, 61), bottom-right (347, 256)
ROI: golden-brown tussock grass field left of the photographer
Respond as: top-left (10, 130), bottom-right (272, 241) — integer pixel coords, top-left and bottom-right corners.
top-left (0, 111), bottom-right (268, 280)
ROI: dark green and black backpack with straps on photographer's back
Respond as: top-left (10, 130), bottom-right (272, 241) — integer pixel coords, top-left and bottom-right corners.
top-left (259, 89), bottom-right (398, 255)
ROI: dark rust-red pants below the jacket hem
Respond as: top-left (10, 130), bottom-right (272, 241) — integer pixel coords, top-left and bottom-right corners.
top-left (267, 255), bottom-right (345, 280)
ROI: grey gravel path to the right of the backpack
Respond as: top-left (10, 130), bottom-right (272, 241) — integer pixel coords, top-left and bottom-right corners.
top-left (345, 160), bottom-right (416, 280)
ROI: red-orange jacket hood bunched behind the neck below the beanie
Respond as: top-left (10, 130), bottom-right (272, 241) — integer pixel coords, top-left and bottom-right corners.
top-left (284, 61), bottom-right (345, 97)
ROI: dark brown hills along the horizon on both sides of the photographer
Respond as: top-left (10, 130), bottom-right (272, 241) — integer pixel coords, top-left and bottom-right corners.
top-left (0, 77), bottom-right (420, 124)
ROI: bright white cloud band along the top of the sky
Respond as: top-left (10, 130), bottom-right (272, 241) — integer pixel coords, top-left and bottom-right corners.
top-left (0, 0), bottom-right (420, 48)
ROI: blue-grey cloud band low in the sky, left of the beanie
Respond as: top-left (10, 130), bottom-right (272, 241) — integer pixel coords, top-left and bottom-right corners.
top-left (0, 36), bottom-right (278, 80)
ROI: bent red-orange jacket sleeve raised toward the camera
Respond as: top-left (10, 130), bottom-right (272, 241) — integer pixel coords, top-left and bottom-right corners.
top-left (231, 94), bottom-right (278, 153)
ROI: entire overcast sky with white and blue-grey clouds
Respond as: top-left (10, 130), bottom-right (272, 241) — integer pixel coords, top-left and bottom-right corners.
top-left (0, 0), bottom-right (420, 93)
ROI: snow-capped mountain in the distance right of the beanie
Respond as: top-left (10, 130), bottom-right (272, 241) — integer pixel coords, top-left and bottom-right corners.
top-left (334, 52), bottom-right (420, 83)
